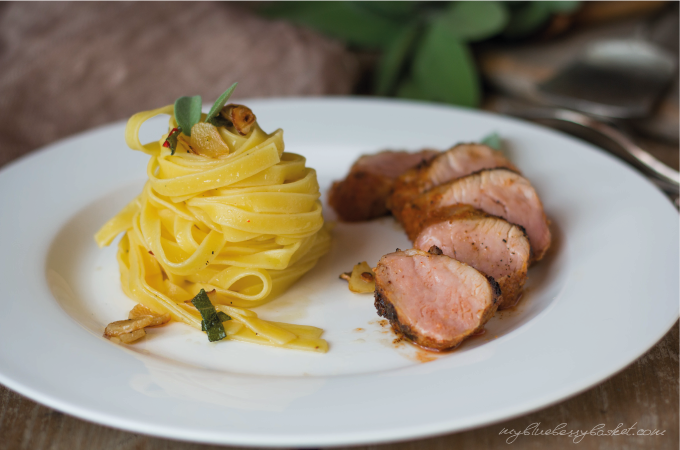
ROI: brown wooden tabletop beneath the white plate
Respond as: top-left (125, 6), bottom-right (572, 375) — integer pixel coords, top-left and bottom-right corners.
top-left (0, 17), bottom-right (680, 450)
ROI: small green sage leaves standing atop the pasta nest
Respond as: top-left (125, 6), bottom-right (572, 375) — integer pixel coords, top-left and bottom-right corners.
top-left (163, 83), bottom-right (238, 155)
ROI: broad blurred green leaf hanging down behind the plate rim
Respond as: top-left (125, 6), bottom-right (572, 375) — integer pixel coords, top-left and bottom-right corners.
top-left (413, 18), bottom-right (480, 107)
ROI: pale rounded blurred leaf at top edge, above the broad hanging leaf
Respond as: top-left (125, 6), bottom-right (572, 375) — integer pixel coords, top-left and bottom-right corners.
top-left (441, 0), bottom-right (509, 41)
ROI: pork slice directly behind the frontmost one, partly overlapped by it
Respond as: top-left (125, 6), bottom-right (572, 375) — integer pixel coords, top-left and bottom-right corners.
top-left (413, 205), bottom-right (531, 309)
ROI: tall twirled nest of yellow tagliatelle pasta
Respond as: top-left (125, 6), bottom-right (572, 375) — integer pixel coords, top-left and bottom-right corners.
top-left (95, 101), bottom-right (330, 352)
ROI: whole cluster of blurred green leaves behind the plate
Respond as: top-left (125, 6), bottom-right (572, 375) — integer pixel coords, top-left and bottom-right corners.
top-left (262, 0), bottom-right (582, 107)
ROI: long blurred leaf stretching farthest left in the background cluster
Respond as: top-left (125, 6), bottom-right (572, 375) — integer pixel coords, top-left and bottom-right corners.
top-left (264, 0), bottom-right (404, 49)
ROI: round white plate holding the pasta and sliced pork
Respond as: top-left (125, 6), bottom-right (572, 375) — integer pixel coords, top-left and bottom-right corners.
top-left (0, 99), bottom-right (680, 446)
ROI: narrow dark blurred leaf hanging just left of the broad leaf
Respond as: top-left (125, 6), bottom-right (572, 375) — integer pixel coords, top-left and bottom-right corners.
top-left (375, 24), bottom-right (421, 95)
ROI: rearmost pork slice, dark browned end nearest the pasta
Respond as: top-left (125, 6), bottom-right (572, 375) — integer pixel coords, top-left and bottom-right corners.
top-left (328, 150), bottom-right (439, 222)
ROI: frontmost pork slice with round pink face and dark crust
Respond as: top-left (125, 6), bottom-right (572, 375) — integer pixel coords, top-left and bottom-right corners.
top-left (375, 249), bottom-right (500, 350)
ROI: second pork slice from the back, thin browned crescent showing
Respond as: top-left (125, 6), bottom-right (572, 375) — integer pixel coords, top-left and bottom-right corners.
top-left (388, 143), bottom-right (519, 221)
